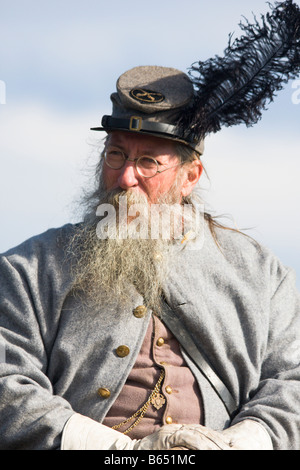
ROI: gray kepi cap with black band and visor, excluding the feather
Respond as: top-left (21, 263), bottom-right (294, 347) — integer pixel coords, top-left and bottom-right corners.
top-left (91, 66), bottom-right (204, 155)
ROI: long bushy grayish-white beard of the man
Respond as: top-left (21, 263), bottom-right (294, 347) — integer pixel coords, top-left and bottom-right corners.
top-left (69, 173), bottom-right (200, 312)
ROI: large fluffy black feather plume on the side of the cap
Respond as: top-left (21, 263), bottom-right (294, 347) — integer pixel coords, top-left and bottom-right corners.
top-left (179, 0), bottom-right (300, 138)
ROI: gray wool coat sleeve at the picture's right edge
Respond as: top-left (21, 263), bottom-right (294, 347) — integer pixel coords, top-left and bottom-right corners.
top-left (233, 270), bottom-right (300, 450)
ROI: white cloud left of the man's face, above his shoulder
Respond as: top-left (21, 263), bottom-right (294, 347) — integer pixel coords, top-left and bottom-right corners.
top-left (0, 103), bottom-right (102, 251)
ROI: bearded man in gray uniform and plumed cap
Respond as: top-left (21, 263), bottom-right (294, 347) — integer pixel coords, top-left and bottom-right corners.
top-left (0, 1), bottom-right (300, 450)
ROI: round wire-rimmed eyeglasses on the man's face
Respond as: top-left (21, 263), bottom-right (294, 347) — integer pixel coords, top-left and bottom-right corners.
top-left (103, 147), bottom-right (182, 178)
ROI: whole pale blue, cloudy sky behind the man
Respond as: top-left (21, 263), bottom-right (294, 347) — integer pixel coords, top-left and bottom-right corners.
top-left (0, 0), bottom-right (300, 286)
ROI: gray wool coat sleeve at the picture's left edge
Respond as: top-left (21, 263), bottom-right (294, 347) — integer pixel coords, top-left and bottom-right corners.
top-left (0, 257), bottom-right (73, 450)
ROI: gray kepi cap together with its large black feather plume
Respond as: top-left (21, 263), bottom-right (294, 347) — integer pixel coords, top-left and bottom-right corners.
top-left (93, 0), bottom-right (300, 159)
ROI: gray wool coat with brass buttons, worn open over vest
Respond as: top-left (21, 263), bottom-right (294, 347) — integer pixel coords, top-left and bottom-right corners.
top-left (0, 225), bottom-right (300, 450)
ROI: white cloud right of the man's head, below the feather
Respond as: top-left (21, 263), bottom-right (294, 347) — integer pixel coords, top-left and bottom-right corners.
top-left (199, 126), bottom-right (300, 286)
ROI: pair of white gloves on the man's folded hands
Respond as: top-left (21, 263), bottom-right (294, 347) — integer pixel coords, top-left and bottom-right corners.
top-left (61, 413), bottom-right (271, 450)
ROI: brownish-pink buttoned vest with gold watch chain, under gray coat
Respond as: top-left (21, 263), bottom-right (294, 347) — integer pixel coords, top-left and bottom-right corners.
top-left (103, 316), bottom-right (203, 439)
